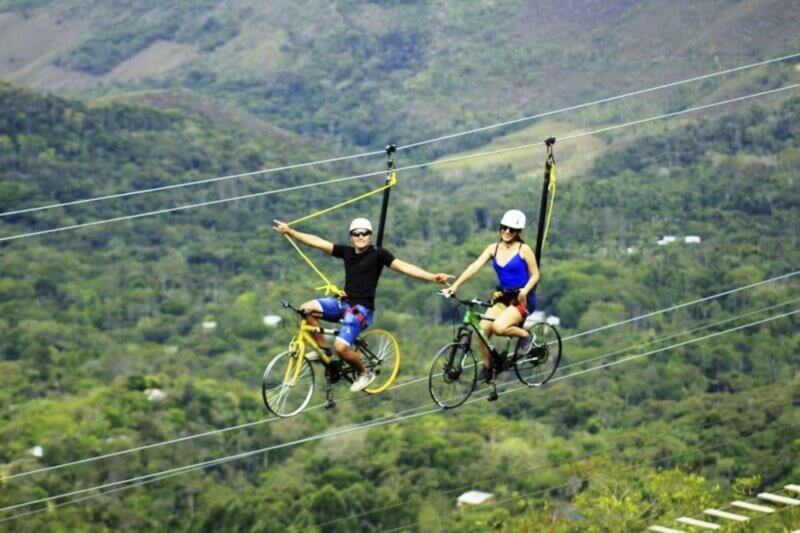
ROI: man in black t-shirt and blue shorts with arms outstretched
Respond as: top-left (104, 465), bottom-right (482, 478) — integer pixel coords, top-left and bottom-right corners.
top-left (273, 218), bottom-right (453, 392)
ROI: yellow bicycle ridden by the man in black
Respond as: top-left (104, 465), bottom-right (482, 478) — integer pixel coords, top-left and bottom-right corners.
top-left (261, 301), bottom-right (400, 417)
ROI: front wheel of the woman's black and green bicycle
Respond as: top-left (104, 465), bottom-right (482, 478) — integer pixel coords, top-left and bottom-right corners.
top-left (428, 342), bottom-right (478, 409)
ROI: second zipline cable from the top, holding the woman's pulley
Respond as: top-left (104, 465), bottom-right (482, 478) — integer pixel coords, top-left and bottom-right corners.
top-left (0, 83), bottom-right (800, 242)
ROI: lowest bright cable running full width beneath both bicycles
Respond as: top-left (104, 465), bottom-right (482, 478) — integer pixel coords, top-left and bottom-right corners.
top-left (0, 309), bottom-right (800, 521)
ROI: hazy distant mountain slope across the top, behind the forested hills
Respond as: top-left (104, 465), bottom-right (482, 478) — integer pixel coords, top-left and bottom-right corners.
top-left (0, 0), bottom-right (800, 149)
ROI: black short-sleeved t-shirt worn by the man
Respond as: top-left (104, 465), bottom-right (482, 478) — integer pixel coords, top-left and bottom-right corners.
top-left (331, 244), bottom-right (394, 309)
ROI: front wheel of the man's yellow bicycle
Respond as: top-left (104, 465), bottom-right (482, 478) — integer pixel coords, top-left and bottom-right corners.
top-left (261, 350), bottom-right (314, 417)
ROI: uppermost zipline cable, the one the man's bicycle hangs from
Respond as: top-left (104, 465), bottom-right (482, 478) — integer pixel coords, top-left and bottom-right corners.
top-left (0, 52), bottom-right (800, 218)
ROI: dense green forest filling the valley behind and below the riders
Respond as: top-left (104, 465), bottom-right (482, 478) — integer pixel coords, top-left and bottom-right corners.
top-left (0, 78), bottom-right (800, 531)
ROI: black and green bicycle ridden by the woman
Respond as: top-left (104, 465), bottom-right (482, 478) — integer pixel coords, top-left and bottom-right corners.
top-left (428, 292), bottom-right (561, 409)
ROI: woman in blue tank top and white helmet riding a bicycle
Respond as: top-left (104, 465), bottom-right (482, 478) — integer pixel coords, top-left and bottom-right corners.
top-left (443, 209), bottom-right (539, 382)
